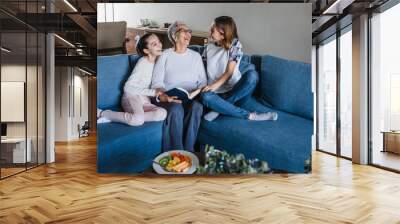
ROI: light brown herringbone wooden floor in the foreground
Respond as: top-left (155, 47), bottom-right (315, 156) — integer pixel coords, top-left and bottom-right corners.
top-left (0, 134), bottom-right (400, 224)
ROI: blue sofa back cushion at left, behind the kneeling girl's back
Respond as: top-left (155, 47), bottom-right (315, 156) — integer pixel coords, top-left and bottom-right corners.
top-left (97, 55), bottom-right (131, 111)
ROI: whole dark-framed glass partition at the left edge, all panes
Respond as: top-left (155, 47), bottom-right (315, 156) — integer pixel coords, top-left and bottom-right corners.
top-left (0, 1), bottom-right (46, 178)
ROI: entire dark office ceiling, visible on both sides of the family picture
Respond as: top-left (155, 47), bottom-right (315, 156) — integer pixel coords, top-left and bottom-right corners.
top-left (0, 0), bottom-right (394, 74)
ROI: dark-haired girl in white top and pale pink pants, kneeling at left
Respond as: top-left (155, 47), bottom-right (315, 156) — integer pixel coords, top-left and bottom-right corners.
top-left (97, 33), bottom-right (174, 126)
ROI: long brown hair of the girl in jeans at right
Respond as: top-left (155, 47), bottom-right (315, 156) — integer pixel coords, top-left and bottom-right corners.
top-left (214, 16), bottom-right (239, 50)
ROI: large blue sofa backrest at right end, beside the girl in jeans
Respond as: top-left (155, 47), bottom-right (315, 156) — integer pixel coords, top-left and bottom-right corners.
top-left (260, 55), bottom-right (313, 120)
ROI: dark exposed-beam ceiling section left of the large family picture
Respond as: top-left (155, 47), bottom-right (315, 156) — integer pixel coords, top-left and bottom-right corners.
top-left (0, 0), bottom-right (97, 73)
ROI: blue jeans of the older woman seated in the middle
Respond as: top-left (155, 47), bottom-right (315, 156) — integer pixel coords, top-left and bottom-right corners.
top-left (153, 100), bottom-right (203, 152)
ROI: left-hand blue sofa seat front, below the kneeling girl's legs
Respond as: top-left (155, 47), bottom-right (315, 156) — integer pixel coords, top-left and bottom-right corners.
top-left (97, 122), bottom-right (163, 173)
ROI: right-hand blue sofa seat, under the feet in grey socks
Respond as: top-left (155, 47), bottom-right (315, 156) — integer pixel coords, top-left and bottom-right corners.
top-left (199, 98), bottom-right (313, 173)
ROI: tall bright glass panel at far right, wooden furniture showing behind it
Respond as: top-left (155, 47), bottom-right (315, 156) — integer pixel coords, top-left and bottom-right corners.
top-left (370, 4), bottom-right (400, 170)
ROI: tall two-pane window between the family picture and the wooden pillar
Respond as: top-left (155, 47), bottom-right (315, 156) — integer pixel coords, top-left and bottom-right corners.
top-left (317, 25), bottom-right (353, 159)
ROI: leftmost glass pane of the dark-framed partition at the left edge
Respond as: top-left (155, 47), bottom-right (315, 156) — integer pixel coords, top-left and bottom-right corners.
top-left (0, 29), bottom-right (27, 177)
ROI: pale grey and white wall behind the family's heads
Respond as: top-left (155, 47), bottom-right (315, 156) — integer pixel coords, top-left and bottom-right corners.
top-left (97, 3), bottom-right (312, 63)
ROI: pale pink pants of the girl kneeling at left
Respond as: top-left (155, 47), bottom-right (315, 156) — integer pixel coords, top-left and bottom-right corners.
top-left (102, 94), bottom-right (167, 126)
